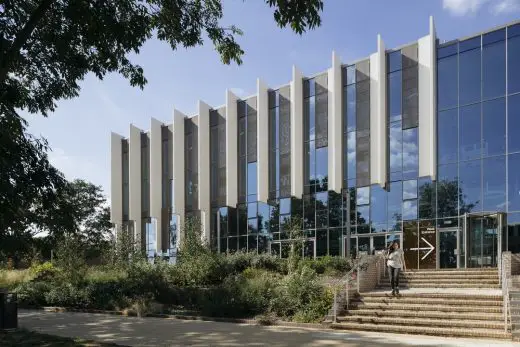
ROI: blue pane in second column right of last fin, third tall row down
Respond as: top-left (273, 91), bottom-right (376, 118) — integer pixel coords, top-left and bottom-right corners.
top-left (459, 160), bottom-right (482, 214)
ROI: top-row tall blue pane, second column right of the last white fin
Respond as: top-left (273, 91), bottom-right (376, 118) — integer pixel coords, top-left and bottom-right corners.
top-left (459, 49), bottom-right (481, 105)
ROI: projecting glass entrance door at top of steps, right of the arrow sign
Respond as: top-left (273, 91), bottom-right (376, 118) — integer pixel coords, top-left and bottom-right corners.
top-left (464, 213), bottom-right (506, 268)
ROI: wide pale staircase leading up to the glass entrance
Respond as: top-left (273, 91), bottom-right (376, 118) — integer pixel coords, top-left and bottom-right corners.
top-left (331, 269), bottom-right (510, 340)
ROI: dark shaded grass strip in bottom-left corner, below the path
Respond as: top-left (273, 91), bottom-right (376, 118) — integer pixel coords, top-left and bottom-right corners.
top-left (0, 329), bottom-right (125, 347)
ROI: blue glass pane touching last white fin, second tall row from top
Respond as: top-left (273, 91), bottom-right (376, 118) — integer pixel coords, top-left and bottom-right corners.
top-left (437, 108), bottom-right (459, 164)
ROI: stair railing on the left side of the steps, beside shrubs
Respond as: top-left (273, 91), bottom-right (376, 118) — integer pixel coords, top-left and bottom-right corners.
top-left (333, 255), bottom-right (384, 323)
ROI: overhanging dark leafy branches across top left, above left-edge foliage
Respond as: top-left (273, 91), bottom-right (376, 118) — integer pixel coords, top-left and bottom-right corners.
top-left (0, 0), bottom-right (323, 115)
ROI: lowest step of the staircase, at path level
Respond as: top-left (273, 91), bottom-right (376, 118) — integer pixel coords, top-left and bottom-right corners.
top-left (331, 322), bottom-right (511, 339)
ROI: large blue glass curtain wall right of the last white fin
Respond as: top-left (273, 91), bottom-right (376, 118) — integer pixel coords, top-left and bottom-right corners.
top-left (437, 25), bottom-right (520, 260)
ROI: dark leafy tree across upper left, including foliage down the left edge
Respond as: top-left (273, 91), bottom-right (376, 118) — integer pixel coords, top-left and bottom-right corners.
top-left (0, 0), bottom-right (323, 250)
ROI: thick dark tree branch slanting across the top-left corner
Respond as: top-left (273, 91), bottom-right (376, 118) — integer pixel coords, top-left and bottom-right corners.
top-left (0, 0), bottom-right (56, 85)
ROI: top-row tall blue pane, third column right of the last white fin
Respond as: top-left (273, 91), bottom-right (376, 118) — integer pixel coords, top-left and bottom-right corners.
top-left (482, 41), bottom-right (506, 100)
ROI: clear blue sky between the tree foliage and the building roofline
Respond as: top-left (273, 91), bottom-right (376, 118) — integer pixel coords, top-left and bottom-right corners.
top-left (27, 0), bottom-right (520, 201)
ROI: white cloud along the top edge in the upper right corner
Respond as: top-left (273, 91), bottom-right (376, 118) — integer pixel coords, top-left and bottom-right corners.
top-left (442, 0), bottom-right (520, 16)
